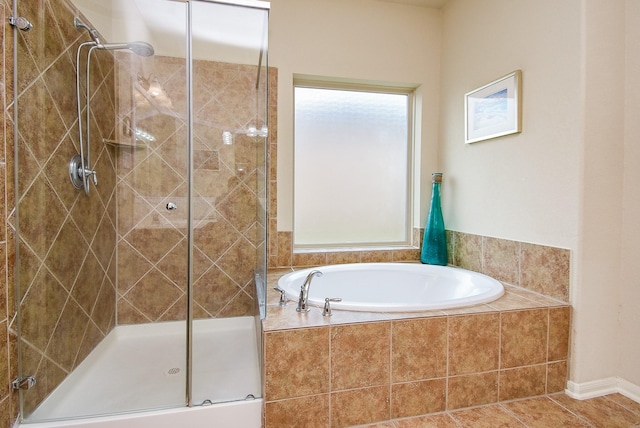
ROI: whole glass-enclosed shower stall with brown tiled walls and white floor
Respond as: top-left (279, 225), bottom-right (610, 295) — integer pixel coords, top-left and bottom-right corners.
top-left (7, 0), bottom-right (269, 426)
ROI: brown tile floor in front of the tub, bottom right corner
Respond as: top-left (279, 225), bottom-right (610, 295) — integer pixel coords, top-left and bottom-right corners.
top-left (352, 393), bottom-right (640, 428)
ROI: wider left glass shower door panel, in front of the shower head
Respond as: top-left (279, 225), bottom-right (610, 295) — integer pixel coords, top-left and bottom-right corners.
top-left (8, 0), bottom-right (189, 422)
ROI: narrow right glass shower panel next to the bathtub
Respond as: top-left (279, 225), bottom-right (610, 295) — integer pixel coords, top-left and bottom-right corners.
top-left (190, 1), bottom-right (268, 405)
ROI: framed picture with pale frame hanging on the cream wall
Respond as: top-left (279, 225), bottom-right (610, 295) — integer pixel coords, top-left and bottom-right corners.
top-left (464, 70), bottom-right (522, 144)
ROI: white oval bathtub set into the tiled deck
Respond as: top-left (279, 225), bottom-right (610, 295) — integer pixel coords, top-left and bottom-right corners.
top-left (278, 263), bottom-right (504, 312)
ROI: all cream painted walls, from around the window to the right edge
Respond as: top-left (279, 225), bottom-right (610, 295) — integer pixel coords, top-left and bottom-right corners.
top-left (270, 0), bottom-right (640, 392)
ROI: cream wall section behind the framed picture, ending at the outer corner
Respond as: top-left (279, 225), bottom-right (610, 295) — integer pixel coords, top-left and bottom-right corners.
top-left (439, 0), bottom-right (582, 248)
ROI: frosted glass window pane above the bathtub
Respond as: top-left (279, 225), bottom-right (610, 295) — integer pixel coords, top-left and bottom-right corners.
top-left (294, 86), bottom-right (411, 248)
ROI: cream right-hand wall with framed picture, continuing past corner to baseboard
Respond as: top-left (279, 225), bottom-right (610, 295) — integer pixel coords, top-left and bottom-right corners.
top-left (439, 0), bottom-right (640, 389)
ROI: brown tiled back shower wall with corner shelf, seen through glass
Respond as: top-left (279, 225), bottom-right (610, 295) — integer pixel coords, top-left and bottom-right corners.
top-left (114, 54), bottom-right (276, 324)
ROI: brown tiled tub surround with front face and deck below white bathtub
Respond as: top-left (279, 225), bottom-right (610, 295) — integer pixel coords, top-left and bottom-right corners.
top-left (263, 272), bottom-right (571, 428)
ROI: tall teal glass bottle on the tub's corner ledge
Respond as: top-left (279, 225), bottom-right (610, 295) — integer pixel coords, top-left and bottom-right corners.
top-left (420, 172), bottom-right (447, 266)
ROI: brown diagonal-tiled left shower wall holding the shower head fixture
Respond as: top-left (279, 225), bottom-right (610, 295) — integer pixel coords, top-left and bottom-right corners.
top-left (0, 0), bottom-right (116, 420)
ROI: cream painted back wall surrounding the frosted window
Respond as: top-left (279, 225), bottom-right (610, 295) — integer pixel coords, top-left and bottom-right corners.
top-left (269, 0), bottom-right (441, 231)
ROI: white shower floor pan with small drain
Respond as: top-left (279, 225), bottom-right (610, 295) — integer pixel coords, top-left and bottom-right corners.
top-left (29, 317), bottom-right (262, 427)
